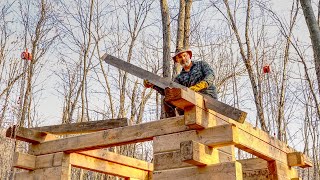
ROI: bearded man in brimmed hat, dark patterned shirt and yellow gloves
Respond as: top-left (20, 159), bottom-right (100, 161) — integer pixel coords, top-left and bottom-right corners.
top-left (143, 50), bottom-right (217, 117)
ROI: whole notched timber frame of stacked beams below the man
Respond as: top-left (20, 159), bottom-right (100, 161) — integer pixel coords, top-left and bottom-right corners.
top-left (7, 88), bottom-right (312, 180)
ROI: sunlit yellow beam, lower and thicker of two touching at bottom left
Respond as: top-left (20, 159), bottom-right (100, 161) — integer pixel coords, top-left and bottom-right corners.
top-left (70, 153), bottom-right (148, 180)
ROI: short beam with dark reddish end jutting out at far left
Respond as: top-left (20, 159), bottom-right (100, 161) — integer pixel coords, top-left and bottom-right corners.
top-left (6, 125), bottom-right (56, 144)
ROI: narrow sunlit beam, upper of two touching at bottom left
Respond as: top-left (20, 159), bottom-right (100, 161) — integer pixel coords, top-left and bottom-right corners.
top-left (79, 150), bottom-right (153, 171)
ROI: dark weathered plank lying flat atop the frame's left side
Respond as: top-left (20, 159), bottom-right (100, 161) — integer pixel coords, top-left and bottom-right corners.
top-left (31, 118), bottom-right (128, 135)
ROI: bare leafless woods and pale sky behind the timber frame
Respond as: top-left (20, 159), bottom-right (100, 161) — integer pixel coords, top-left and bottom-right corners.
top-left (0, 0), bottom-right (320, 179)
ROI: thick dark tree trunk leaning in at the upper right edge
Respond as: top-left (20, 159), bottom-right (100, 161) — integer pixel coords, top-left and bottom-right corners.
top-left (300, 0), bottom-right (320, 94)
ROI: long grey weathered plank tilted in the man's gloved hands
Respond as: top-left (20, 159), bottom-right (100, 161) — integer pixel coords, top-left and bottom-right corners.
top-left (101, 53), bottom-right (247, 122)
